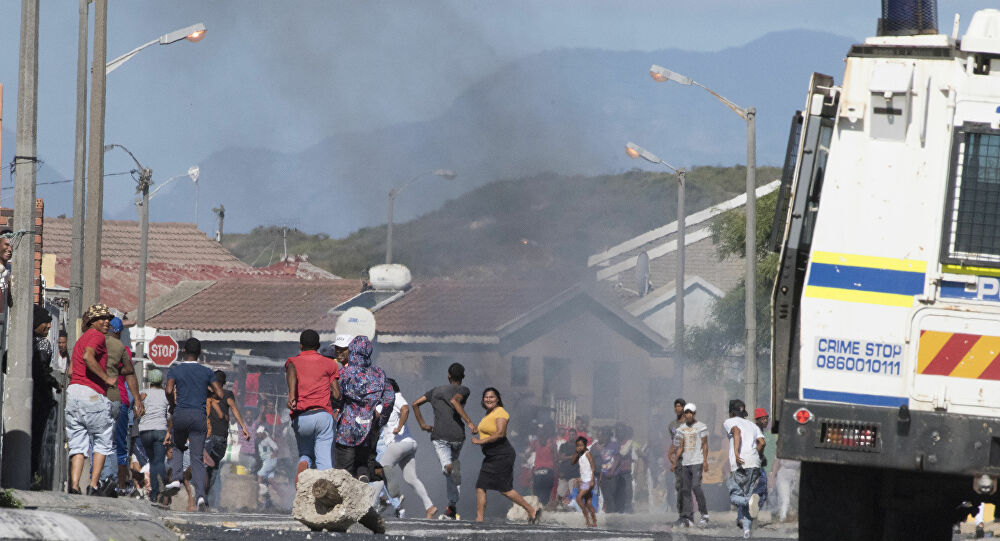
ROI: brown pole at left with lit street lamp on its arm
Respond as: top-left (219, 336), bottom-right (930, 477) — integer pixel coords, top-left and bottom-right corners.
top-left (79, 22), bottom-right (205, 308)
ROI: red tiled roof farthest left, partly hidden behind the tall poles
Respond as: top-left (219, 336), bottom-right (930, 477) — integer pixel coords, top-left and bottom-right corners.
top-left (42, 217), bottom-right (244, 266)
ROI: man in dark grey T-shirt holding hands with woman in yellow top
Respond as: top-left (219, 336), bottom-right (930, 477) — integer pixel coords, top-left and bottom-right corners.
top-left (413, 363), bottom-right (479, 519)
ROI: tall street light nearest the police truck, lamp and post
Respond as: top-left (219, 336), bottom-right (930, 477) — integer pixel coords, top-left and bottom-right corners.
top-left (649, 64), bottom-right (757, 411)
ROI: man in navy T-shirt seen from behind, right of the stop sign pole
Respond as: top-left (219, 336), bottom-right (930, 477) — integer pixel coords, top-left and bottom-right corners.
top-left (163, 338), bottom-right (223, 511)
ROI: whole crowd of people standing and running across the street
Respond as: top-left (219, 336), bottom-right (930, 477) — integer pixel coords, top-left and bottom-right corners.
top-left (32, 304), bottom-right (798, 536)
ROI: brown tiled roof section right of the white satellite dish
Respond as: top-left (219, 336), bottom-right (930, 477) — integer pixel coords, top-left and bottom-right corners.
top-left (375, 279), bottom-right (565, 334)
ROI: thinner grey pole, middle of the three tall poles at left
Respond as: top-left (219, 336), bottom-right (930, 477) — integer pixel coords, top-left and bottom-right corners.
top-left (66, 0), bottom-right (91, 351)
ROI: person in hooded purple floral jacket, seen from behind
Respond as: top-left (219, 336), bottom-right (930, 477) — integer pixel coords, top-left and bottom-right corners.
top-left (334, 336), bottom-right (396, 482)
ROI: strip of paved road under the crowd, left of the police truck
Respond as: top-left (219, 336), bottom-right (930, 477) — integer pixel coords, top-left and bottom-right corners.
top-left (166, 513), bottom-right (789, 541)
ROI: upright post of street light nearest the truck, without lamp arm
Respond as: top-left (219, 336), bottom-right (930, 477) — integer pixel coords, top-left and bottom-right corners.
top-left (743, 107), bottom-right (757, 412)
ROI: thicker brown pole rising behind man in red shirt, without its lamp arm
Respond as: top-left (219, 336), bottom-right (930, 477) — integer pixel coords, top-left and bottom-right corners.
top-left (82, 0), bottom-right (108, 306)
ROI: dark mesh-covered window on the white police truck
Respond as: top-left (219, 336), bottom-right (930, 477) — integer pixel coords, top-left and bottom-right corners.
top-left (941, 123), bottom-right (1000, 267)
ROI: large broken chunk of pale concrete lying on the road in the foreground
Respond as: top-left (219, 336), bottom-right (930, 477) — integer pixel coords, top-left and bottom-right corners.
top-left (292, 469), bottom-right (385, 533)
